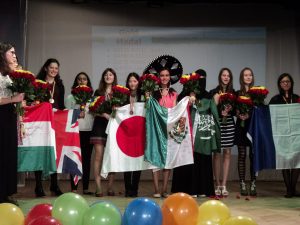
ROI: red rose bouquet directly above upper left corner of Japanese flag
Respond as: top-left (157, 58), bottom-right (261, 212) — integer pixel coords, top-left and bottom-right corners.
top-left (110, 85), bottom-right (130, 118)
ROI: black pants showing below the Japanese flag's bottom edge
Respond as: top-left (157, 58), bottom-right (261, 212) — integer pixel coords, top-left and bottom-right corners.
top-left (124, 171), bottom-right (141, 195)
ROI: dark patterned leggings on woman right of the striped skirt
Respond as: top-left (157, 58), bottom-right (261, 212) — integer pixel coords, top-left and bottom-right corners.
top-left (238, 146), bottom-right (256, 181)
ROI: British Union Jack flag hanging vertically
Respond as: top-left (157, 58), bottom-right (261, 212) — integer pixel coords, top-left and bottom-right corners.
top-left (53, 109), bottom-right (82, 184)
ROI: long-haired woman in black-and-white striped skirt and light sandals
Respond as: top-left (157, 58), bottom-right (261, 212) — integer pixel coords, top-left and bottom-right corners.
top-left (210, 68), bottom-right (235, 196)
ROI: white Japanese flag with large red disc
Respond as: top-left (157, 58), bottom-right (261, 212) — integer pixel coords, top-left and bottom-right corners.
top-left (101, 103), bottom-right (155, 177)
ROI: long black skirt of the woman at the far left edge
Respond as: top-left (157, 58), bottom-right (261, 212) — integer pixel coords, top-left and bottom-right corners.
top-left (0, 104), bottom-right (18, 202)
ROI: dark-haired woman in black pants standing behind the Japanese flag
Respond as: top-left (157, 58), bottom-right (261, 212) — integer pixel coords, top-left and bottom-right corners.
top-left (124, 73), bottom-right (141, 197)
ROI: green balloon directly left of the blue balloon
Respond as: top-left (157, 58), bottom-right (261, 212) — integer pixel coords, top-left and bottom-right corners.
top-left (83, 201), bottom-right (122, 225)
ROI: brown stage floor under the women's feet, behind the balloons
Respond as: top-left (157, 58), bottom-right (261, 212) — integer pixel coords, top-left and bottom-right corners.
top-left (15, 179), bottom-right (300, 225)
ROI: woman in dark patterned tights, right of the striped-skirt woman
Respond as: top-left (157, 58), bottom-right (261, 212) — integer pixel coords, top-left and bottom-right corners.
top-left (235, 67), bottom-right (257, 196)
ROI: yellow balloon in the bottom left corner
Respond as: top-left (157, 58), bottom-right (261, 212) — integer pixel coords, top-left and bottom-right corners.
top-left (0, 203), bottom-right (24, 225)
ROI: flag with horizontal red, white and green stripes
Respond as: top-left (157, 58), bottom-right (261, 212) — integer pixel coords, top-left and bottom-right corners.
top-left (18, 103), bottom-right (56, 176)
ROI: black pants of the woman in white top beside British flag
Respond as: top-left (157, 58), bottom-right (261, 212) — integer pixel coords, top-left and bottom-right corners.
top-left (70, 131), bottom-right (93, 190)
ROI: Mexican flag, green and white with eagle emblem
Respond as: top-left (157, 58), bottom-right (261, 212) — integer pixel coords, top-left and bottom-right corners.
top-left (145, 97), bottom-right (194, 169)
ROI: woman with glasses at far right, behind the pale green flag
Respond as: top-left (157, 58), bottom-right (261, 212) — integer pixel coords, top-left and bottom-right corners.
top-left (269, 73), bottom-right (300, 198)
